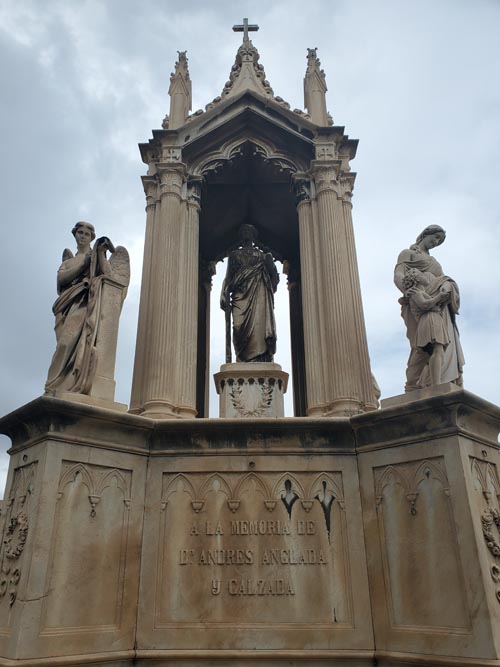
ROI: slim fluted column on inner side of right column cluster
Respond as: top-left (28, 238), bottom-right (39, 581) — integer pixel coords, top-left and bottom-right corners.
top-left (294, 178), bottom-right (327, 416)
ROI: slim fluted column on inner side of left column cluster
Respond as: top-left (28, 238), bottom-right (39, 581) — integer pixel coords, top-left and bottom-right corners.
top-left (176, 179), bottom-right (201, 417)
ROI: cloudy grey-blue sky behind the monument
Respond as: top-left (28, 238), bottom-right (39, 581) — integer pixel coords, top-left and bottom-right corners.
top-left (0, 0), bottom-right (500, 495)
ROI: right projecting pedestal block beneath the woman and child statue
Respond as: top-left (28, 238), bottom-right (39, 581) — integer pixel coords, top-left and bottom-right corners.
top-left (351, 385), bottom-right (500, 667)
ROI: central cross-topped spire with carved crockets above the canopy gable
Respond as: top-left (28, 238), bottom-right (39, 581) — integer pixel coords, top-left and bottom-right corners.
top-left (221, 19), bottom-right (273, 98)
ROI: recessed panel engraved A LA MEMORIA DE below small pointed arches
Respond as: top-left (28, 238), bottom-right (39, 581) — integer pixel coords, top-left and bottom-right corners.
top-left (156, 472), bottom-right (352, 627)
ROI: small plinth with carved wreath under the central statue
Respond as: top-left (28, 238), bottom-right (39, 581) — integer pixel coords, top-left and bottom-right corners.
top-left (214, 362), bottom-right (288, 419)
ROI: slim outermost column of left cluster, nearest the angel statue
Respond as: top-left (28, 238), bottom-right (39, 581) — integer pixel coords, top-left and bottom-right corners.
top-left (130, 176), bottom-right (159, 414)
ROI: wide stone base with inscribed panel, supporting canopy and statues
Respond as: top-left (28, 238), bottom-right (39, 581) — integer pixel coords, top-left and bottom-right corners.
top-left (0, 390), bottom-right (500, 667)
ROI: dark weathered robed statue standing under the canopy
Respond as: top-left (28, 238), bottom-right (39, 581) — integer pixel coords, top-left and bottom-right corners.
top-left (220, 225), bottom-right (279, 363)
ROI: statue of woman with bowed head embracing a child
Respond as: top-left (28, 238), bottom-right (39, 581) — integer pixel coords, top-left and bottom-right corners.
top-left (394, 225), bottom-right (464, 391)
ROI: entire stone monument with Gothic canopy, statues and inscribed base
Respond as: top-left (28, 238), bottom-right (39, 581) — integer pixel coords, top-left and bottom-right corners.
top-left (0, 19), bottom-right (500, 667)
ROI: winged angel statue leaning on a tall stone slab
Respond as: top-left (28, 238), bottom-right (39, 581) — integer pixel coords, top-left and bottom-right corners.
top-left (45, 222), bottom-right (130, 395)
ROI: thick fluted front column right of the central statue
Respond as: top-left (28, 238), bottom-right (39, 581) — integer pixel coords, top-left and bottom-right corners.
top-left (312, 159), bottom-right (371, 415)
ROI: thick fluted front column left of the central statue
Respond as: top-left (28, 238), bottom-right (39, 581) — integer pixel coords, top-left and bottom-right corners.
top-left (138, 163), bottom-right (187, 419)
